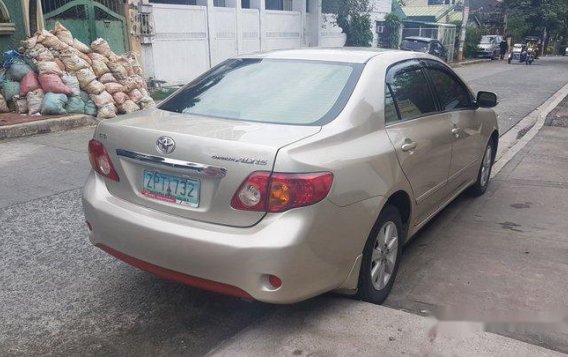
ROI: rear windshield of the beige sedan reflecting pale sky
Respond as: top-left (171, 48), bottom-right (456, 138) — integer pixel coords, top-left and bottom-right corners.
top-left (160, 59), bottom-right (363, 125)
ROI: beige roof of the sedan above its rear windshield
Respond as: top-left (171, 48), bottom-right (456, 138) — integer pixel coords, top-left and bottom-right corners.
top-left (236, 47), bottom-right (398, 63)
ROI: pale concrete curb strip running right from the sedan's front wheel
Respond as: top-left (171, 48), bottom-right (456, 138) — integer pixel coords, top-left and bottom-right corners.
top-left (491, 83), bottom-right (568, 177)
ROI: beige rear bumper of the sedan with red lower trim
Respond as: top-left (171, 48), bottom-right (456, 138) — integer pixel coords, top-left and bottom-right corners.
top-left (83, 173), bottom-right (381, 303)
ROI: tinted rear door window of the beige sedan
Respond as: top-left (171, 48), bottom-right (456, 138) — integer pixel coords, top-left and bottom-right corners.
top-left (385, 68), bottom-right (436, 121)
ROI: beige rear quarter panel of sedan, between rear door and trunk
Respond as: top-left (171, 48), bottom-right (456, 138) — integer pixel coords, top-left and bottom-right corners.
top-left (274, 55), bottom-right (412, 249)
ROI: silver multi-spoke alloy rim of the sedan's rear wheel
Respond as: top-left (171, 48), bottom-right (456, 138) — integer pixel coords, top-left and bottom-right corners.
top-left (371, 221), bottom-right (398, 290)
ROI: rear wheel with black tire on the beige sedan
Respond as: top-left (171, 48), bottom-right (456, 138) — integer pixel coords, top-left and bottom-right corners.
top-left (357, 205), bottom-right (405, 304)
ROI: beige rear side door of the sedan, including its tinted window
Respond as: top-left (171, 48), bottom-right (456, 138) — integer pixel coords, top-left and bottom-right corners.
top-left (385, 60), bottom-right (452, 221)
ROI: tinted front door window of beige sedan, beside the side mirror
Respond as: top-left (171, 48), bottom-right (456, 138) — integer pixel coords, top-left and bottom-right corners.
top-left (428, 68), bottom-right (471, 111)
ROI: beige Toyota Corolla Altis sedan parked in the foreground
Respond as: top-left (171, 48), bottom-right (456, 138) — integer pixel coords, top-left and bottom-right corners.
top-left (83, 49), bottom-right (499, 303)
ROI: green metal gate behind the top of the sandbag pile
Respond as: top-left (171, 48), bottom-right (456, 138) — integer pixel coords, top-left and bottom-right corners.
top-left (41, 0), bottom-right (129, 54)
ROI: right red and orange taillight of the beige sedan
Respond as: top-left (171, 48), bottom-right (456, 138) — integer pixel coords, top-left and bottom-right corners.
top-left (231, 171), bottom-right (333, 212)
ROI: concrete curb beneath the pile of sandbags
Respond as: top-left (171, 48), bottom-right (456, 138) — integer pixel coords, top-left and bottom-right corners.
top-left (0, 114), bottom-right (99, 140)
